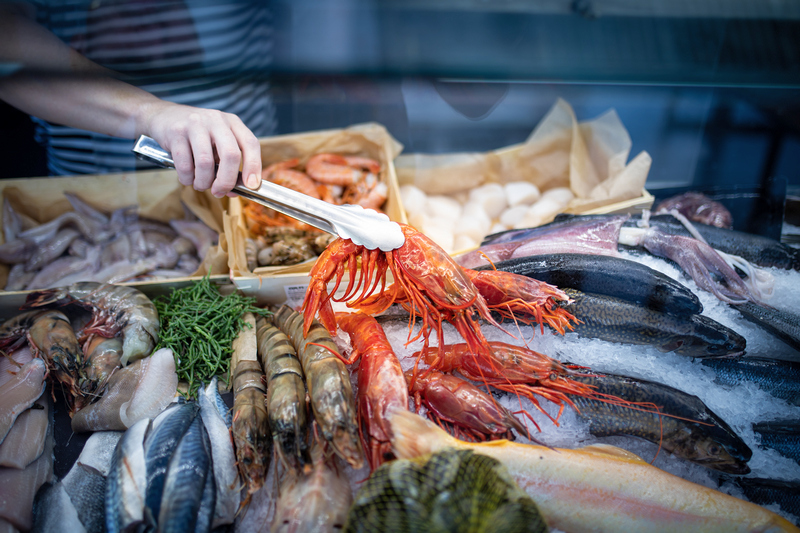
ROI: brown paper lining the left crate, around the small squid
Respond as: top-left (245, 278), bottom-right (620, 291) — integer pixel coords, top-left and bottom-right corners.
top-left (0, 170), bottom-right (229, 287)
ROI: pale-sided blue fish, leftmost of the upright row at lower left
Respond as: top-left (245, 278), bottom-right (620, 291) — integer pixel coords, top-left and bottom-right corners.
top-left (105, 419), bottom-right (152, 533)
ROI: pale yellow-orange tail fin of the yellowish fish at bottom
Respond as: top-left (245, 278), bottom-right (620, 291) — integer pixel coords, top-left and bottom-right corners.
top-left (390, 410), bottom-right (454, 459)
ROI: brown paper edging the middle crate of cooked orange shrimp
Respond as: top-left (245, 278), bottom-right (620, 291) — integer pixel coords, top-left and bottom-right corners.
top-left (230, 123), bottom-right (407, 276)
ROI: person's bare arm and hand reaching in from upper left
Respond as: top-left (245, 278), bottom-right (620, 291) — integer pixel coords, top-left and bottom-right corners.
top-left (0, 7), bottom-right (261, 196)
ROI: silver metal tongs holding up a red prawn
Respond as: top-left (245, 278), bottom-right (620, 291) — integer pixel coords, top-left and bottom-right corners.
top-left (133, 135), bottom-right (405, 252)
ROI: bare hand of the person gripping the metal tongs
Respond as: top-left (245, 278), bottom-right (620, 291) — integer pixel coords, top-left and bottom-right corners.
top-left (140, 100), bottom-right (261, 198)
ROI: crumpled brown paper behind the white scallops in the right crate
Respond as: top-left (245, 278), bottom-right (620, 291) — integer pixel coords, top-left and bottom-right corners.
top-left (395, 98), bottom-right (652, 213)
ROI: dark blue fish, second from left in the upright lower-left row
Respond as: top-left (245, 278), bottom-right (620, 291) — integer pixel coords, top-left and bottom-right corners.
top-left (144, 402), bottom-right (198, 522)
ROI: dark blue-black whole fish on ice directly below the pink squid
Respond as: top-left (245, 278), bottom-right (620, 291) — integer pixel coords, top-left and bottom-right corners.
top-left (480, 253), bottom-right (703, 316)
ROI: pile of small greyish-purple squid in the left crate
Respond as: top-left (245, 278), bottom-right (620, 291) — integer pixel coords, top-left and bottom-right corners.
top-left (0, 193), bottom-right (219, 291)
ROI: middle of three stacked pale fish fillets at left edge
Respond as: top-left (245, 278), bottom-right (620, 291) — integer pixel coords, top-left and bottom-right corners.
top-left (0, 394), bottom-right (50, 469)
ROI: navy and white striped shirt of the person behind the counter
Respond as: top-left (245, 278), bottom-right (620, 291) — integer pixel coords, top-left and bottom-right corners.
top-left (34, 0), bottom-right (277, 175)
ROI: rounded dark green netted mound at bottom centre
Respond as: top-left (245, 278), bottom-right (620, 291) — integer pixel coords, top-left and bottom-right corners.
top-left (344, 444), bottom-right (549, 533)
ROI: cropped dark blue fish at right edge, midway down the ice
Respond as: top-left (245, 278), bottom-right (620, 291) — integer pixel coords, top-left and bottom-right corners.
top-left (701, 356), bottom-right (800, 405)
